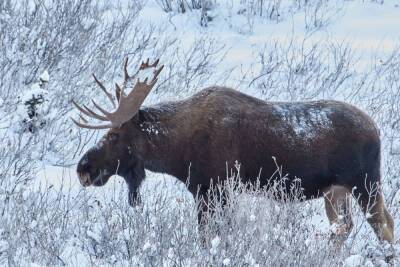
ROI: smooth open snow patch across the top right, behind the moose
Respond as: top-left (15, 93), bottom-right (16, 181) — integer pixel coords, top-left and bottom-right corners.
top-left (134, 1), bottom-right (400, 82)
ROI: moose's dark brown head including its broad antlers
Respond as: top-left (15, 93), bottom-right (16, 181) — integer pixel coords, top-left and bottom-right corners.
top-left (72, 59), bottom-right (164, 201)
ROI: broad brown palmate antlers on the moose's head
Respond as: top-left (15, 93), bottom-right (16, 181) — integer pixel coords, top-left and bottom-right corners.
top-left (71, 58), bottom-right (164, 129)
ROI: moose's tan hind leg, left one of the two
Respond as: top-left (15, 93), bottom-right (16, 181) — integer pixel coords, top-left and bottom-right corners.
top-left (324, 185), bottom-right (353, 241)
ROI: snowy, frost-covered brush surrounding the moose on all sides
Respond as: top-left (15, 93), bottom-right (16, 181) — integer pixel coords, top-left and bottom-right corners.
top-left (0, 0), bottom-right (400, 266)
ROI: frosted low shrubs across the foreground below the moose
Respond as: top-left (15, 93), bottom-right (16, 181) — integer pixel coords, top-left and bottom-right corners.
top-left (0, 169), bottom-right (396, 266)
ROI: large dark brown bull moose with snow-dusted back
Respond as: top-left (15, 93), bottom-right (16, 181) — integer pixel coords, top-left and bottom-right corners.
top-left (72, 59), bottom-right (394, 243)
